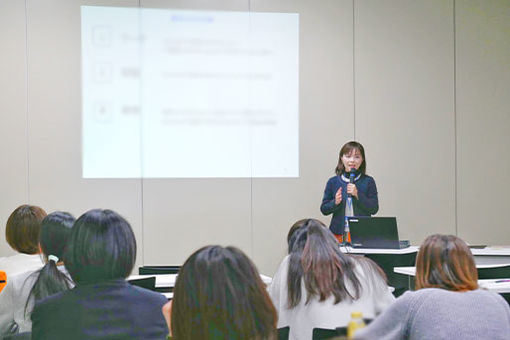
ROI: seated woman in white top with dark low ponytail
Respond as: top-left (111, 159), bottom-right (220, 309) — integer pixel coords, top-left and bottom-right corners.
top-left (0, 212), bottom-right (74, 336)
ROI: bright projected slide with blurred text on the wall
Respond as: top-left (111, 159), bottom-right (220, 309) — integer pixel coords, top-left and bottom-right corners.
top-left (81, 6), bottom-right (299, 178)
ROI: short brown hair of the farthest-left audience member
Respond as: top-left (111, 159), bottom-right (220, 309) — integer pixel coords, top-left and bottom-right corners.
top-left (5, 204), bottom-right (46, 254)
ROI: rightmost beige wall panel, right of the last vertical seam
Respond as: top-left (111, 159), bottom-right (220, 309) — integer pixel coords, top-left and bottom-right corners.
top-left (456, 0), bottom-right (510, 245)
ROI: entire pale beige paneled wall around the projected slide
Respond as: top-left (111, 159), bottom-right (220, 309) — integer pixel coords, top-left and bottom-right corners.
top-left (0, 0), bottom-right (510, 275)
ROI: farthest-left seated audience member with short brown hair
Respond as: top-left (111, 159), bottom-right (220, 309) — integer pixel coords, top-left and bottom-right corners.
top-left (0, 205), bottom-right (46, 276)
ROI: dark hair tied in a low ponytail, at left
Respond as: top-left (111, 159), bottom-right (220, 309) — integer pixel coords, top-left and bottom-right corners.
top-left (25, 211), bottom-right (75, 313)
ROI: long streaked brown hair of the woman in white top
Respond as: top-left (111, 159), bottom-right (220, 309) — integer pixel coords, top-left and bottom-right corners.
top-left (287, 219), bottom-right (362, 308)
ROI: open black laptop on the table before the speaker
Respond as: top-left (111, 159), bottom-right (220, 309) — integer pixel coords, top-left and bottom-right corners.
top-left (349, 217), bottom-right (410, 249)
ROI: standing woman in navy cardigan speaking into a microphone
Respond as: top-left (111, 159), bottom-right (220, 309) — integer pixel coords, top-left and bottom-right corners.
top-left (321, 141), bottom-right (379, 242)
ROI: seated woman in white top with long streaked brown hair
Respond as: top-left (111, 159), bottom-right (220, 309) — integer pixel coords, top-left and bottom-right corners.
top-left (268, 219), bottom-right (395, 339)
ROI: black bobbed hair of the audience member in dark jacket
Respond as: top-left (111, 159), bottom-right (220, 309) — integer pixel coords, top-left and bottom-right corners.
top-left (64, 209), bottom-right (136, 283)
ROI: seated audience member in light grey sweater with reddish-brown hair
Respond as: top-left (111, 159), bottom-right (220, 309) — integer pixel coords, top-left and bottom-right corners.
top-left (355, 235), bottom-right (510, 340)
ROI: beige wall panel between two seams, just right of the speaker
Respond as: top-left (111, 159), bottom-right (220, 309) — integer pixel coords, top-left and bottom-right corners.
top-left (354, 0), bottom-right (455, 242)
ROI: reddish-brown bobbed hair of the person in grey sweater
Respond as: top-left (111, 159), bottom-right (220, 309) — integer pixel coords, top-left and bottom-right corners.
top-left (415, 234), bottom-right (478, 291)
